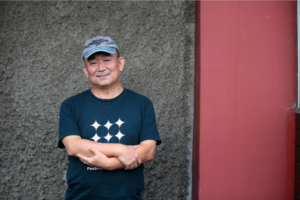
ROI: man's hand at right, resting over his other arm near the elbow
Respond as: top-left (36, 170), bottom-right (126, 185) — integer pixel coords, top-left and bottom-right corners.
top-left (117, 145), bottom-right (142, 170)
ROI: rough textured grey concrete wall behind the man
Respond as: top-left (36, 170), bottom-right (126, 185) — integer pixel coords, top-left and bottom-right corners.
top-left (0, 1), bottom-right (194, 200)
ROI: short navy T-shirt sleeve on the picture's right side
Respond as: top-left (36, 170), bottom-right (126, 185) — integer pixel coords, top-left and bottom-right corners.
top-left (140, 98), bottom-right (161, 145)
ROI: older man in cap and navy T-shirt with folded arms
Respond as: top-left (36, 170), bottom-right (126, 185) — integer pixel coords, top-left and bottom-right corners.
top-left (58, 36), bottom-right (161, 200)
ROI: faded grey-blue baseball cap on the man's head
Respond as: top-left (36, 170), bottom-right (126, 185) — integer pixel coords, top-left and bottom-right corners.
top-left (82, 36), bottom-right (120, 58)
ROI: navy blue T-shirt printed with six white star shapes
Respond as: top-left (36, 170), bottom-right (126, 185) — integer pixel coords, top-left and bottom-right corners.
top-left (58, 89), bottom-right (161, 200)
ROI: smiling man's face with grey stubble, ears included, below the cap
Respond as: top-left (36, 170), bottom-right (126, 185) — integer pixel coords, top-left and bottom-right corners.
top-left (83, 51), bottom-right (125, 88)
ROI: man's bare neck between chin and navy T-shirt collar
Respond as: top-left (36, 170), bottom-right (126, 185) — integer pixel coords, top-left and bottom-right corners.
top-left (91, 84), bottom-right (124, 99)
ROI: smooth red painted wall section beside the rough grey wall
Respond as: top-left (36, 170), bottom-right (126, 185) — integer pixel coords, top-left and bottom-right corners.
top-left (193, 1), bottom-right (297, 200)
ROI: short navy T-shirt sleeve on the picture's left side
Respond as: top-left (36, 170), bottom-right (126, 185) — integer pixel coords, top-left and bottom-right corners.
top-left (58, 99), bottom-right (81, 148)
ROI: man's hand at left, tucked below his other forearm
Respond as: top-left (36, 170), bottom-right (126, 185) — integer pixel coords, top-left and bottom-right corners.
top-left (77, 147), bottom-right (110, 169)
